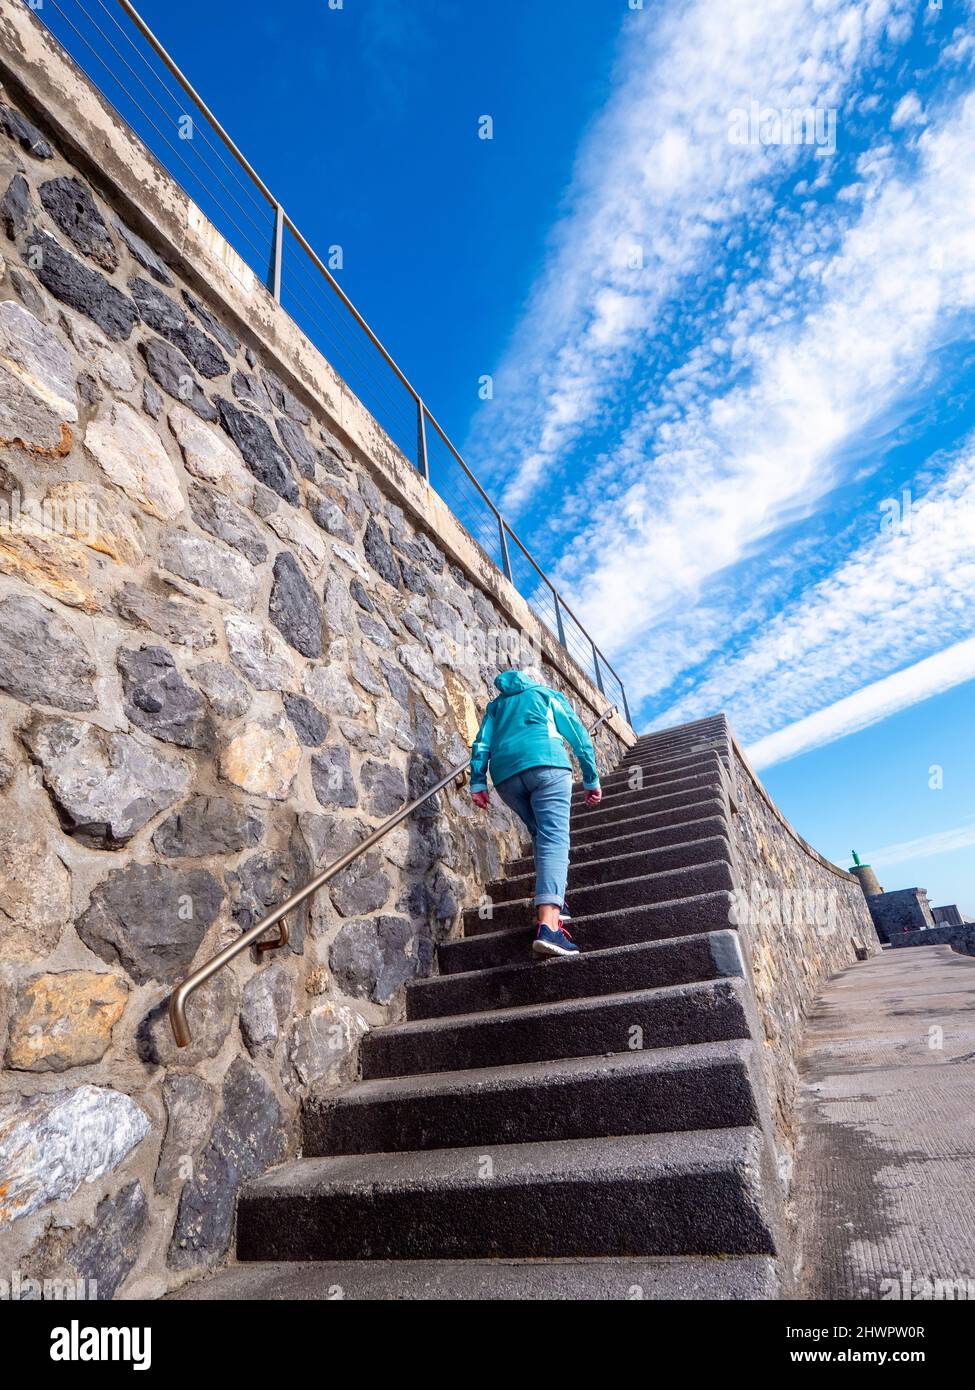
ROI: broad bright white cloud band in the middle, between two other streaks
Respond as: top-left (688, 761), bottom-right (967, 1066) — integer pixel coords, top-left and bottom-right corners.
top-left (562, 88), bottom-right (975, 661)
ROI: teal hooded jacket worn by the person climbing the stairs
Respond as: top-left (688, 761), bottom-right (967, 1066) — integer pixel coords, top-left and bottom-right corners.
top-left (470, 671), bottom-right (599, 791)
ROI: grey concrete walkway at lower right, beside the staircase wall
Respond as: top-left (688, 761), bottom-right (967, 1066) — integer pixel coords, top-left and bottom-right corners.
top-left (796, 947), bottom-right (975, 1300)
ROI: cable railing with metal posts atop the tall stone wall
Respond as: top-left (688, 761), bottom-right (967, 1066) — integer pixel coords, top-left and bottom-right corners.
top-left (22, 0), bottom-right (630, 721)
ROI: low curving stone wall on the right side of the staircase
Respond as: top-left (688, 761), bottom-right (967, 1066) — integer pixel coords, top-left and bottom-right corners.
top-left (726, 735), bottom-right (879, 1183)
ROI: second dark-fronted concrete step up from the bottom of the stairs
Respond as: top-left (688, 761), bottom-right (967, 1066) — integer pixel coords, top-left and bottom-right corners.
top-left (302, 1040), bottom-right (759, 1158)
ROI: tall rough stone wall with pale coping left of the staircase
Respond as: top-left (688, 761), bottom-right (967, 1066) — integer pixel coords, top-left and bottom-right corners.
top-left (0, 67), bottom-right (633, 1297)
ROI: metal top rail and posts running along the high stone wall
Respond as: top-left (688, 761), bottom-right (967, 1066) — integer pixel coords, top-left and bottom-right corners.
top-left (28, 0), bottom-right (630, 723)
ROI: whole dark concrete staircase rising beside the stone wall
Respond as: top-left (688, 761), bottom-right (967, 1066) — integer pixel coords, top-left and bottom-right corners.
top-left (177, 719), bottom-right (784, 1298)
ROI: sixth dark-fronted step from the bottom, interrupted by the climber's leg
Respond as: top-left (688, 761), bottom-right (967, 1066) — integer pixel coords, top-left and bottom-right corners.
top-left (463, 841), bottom-right (734, 937)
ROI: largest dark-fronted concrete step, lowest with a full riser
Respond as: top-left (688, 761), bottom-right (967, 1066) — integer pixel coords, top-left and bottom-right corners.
top-left (236, 1127), bottom-right (775, 1261)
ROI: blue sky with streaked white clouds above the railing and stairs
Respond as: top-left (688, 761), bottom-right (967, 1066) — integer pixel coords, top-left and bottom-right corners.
top-left (49, 0), bottom-right (975, 917)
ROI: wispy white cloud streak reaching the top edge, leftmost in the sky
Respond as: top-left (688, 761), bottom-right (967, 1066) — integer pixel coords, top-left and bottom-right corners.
top-left (472, 0), bottom-right (911, 514)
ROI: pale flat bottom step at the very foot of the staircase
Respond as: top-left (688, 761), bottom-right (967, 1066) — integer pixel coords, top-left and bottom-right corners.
top-left (168, 1255), bottom-right (779, 1302)
